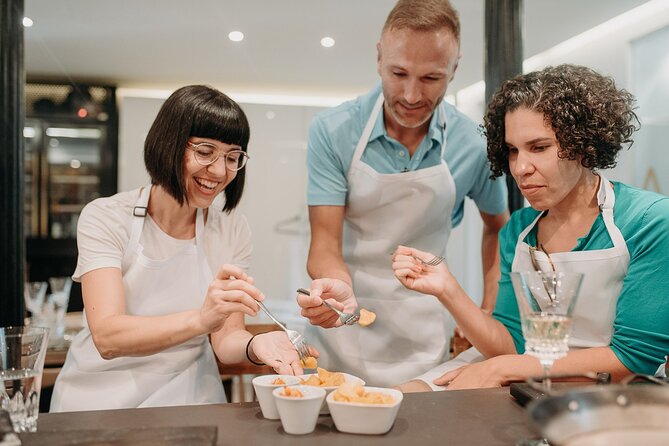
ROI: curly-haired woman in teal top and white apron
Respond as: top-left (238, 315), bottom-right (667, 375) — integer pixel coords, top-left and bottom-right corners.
top-left (392, 65), bottom-right (669, 391)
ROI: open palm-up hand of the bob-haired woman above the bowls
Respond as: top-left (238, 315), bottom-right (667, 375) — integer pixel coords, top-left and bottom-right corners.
top-left (249, 331), bottom-right (319, 375)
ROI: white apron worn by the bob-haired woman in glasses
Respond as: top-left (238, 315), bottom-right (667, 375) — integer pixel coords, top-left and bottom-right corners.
top-left (51, 186), bottom-right (225, 412)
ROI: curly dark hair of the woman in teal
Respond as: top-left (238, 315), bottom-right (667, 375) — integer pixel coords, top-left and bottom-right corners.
top-left (483, 64), bottom-right (639, 178)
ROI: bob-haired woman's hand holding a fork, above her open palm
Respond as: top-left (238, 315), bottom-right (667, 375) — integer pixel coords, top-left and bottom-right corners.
top-left (199, 265), bottom-right (265, 333)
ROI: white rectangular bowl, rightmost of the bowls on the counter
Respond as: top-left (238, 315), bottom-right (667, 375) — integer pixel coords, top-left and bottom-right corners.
top-left (325, 387), bottom-right (404, 435)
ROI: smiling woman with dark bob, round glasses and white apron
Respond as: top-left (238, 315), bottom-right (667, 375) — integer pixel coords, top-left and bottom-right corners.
top-left (51, 85), bottom-right (317, 411)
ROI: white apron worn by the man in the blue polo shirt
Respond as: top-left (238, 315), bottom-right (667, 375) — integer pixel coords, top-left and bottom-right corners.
top-left (308, 95), bottom-right (455, 386)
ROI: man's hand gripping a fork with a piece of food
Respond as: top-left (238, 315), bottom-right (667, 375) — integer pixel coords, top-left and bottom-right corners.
top-left (297, 278), bottom-right (358, 328)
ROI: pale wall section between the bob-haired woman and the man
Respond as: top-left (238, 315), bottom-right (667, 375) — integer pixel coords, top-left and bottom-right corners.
top-left (232, 104), bottom-right (320, 311)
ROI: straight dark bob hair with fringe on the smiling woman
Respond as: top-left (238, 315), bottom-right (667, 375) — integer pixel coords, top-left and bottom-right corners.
top-left (144, 85), bottom-right (251, 212)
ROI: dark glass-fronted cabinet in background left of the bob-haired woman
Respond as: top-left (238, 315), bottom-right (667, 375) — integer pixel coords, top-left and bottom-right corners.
top-left (23, 82), bottom-right (118, 310)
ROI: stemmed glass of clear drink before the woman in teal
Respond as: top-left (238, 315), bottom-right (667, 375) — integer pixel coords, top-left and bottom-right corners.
top-left (511, 271), bottom-right (583, 388)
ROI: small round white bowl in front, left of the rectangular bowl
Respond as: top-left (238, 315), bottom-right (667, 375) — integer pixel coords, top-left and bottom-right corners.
top-left (272, 386), bottom-right (325, 435)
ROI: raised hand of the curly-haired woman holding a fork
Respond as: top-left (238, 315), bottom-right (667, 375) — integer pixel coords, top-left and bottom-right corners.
top-left (392, 246), bottom-right (454, 297)
